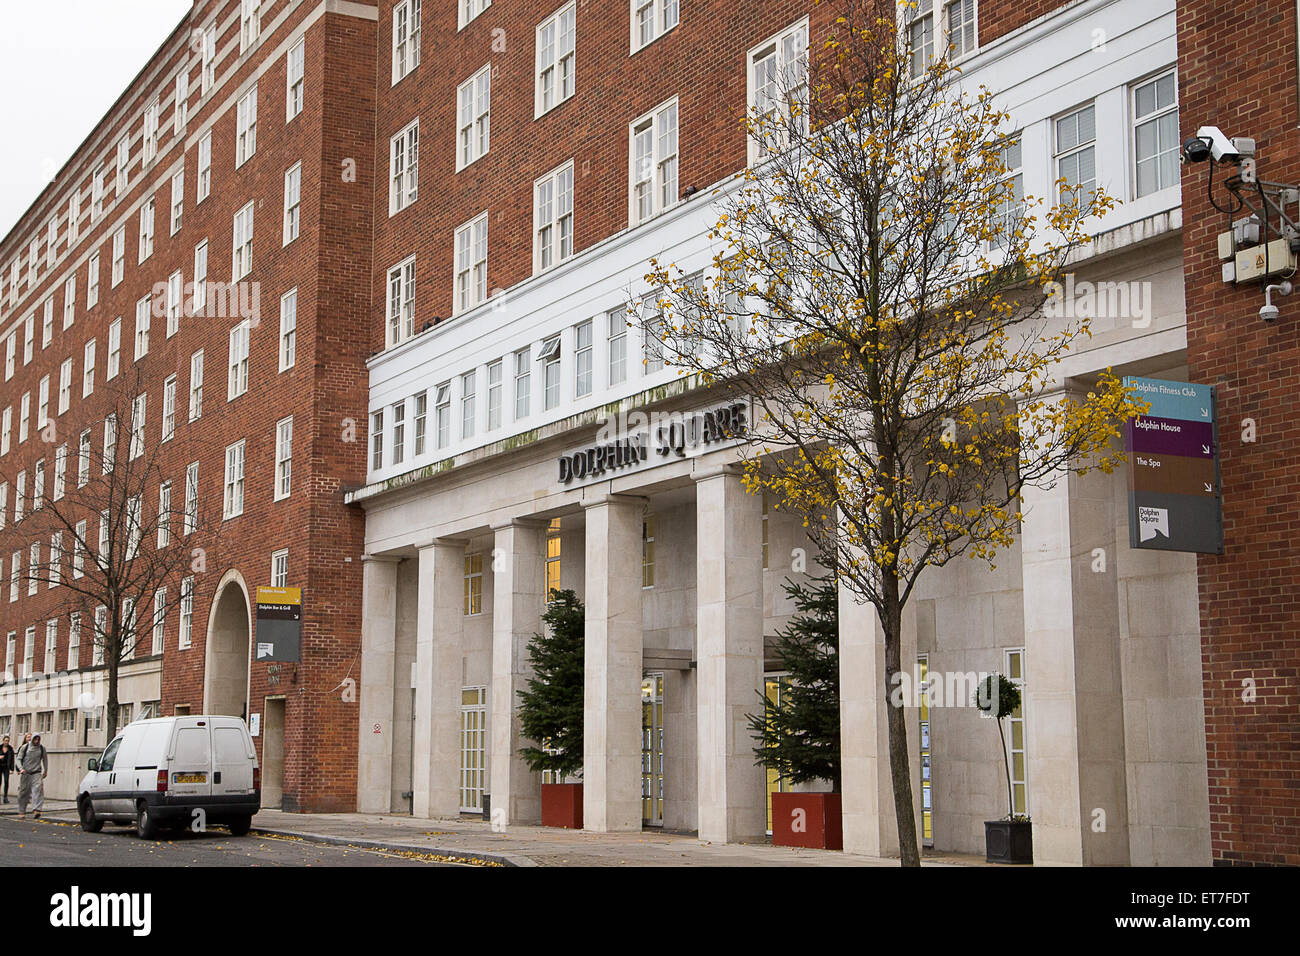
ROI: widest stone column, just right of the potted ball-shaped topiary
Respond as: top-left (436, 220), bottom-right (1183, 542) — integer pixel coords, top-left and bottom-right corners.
top-left (1021, 395), bottom-right (1128, 866)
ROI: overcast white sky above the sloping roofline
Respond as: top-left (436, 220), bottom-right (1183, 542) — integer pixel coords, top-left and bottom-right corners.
top-left (0, 0), bottom-right (191, 237)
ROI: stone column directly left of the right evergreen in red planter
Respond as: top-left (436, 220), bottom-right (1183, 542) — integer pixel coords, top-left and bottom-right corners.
top-left (696, 470), bottom-right (767, 843)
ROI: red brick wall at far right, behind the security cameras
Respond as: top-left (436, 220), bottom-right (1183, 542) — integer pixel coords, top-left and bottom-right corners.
top-left (1178, 0), bottom-right (1300, 865)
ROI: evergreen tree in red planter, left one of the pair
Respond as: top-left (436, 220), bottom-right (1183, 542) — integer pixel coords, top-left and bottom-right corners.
top-left (519, 589), bottom-right (586, 829)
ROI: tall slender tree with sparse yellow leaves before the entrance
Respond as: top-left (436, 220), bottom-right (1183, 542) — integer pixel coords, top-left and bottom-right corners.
top-left (642, 0), bottom-right (1143, 865)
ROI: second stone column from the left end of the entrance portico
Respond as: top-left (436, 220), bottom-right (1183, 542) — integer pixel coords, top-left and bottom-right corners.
top-left (412, 540), bottom-right (465, 817)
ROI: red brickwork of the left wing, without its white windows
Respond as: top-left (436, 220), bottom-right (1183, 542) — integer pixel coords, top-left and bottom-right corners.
top-left (0, 0), bottom-right (376, 812)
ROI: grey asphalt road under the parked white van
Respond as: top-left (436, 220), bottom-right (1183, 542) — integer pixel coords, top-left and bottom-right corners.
top-left (0, 817), bottom-right (456, 866)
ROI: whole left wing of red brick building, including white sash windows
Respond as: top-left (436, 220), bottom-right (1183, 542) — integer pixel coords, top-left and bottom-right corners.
top-left (0, 0), bottom-right (376, 810)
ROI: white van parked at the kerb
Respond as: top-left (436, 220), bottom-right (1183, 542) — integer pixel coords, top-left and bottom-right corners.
top-left (77, 715), bottom-right (261, 840)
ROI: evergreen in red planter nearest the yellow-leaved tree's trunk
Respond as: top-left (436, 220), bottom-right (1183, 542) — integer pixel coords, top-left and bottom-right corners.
top-left (746, 574), bottom-right (844, 849)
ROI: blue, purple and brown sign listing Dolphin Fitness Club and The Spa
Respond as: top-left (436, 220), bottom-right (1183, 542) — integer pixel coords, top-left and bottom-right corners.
top-left (1125, 376), bottom-right (1223, 554)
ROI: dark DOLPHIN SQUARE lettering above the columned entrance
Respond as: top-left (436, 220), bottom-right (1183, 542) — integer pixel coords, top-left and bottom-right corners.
top-left (559, 402), bottom-right (749, 485)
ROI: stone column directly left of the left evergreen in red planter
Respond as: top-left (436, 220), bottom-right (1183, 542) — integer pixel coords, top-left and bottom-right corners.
top-left (488, 522), bottom-right (546, 823)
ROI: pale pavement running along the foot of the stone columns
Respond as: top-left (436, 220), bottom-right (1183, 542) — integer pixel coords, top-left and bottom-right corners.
top-left (0, 796), bottom-right (987, 866)
